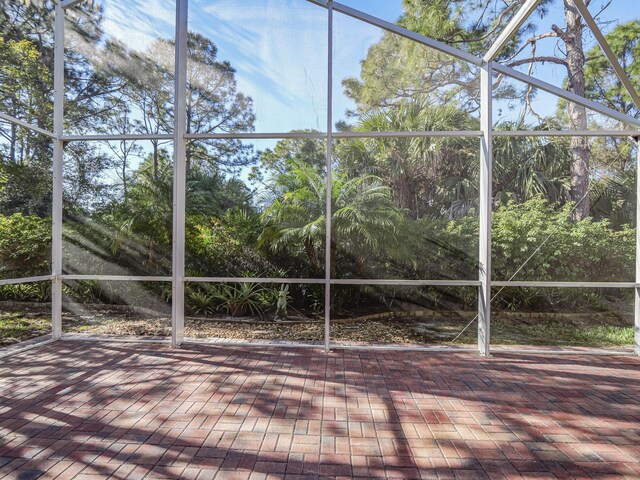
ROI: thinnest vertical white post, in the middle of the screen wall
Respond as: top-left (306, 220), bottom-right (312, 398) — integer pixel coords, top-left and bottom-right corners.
top-left (324, 0), bottom-right (333, 352)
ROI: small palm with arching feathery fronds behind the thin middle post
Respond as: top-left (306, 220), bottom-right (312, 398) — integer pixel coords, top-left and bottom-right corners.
top-left (258, 162), bottom-right (403, 275)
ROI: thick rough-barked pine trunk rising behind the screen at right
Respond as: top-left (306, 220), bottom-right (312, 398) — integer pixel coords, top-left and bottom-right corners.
top-left (563, 0), bottom-right (590, 221)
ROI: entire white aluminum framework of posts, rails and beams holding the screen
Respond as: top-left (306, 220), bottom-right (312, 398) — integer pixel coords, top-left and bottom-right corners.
top-left (0, 0), bottom-right (640, 356)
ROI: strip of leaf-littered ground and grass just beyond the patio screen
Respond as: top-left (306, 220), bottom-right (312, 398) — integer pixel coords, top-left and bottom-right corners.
top-left (0, 308), bottom-right (633, 347)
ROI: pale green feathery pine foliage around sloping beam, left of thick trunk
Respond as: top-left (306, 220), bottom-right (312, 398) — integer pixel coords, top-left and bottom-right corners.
top-left (342, 0), bottom-right (528, 118)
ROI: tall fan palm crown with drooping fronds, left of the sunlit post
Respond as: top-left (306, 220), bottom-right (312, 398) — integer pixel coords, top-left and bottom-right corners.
top-left (336, 103), bottom-right (478, 219)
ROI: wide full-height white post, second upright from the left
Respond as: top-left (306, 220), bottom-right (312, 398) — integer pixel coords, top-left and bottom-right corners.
top-left (171, 0), bottom-right (189, 348)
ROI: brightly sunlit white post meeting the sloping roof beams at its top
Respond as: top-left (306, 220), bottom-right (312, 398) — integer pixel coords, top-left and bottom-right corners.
top-left (478, 62), bottom-right (493, 356)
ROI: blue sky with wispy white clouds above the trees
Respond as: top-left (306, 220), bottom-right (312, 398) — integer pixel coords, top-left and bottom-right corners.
top-left (99, 0), bottom-right (636, 132)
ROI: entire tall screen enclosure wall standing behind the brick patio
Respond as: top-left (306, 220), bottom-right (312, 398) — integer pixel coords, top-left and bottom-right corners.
top-left (0, 0), bottom-right (640, 356)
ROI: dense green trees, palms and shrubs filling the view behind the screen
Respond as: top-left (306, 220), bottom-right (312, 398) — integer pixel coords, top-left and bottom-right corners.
top-left (0, 1), bottom-right (640, 330)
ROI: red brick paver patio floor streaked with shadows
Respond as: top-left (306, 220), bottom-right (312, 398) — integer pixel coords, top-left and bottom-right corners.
top-left (0, 342), bottom-right (640, 479)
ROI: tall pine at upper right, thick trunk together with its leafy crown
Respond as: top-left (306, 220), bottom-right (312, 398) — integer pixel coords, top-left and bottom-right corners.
top-left (343, 0), bottom-right (633, 220)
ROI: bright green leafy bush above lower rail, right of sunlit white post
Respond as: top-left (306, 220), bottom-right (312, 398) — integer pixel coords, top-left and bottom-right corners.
top-left (492, 197), bottom-right (635, 282)
